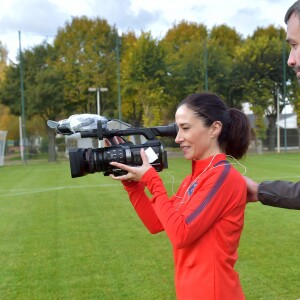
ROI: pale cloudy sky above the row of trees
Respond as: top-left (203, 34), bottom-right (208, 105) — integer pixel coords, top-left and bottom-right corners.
top-left (0, 0), bottom-right (294, 61)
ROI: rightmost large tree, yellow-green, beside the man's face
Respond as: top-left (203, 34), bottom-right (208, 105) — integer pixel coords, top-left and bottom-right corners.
top-left (233, 26), bottom-right (293, 150)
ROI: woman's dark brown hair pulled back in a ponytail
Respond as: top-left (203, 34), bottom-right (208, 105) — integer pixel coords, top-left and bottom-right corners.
top-left (178, 92), bottom-right (251, 159)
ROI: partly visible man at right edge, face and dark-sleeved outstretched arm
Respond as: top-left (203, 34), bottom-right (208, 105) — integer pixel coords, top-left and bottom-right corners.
top-left (245, 0), bottom-right (300, 209)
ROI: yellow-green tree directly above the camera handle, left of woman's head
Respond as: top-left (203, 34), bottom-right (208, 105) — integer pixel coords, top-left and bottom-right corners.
top-left (121, 32), bottom-right (168, 126)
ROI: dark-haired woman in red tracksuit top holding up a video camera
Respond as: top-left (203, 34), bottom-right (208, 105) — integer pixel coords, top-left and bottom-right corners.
top-left (111, 93), bottom-right (250, 300)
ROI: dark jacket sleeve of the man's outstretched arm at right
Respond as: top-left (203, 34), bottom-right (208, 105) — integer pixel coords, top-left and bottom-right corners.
top-left (258, 180), bottom-right (300, 209)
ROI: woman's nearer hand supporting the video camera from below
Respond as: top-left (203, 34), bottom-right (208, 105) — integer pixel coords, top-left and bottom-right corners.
top-left (110, 148), bottom-right (152, 181)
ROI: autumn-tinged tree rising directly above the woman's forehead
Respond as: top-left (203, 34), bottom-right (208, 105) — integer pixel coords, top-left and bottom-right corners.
top-left (160, 21), bottom-right (208, 115)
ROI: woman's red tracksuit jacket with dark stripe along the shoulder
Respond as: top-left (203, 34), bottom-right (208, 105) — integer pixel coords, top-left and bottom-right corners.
top-left (124, 154), bottom-right (247, 300)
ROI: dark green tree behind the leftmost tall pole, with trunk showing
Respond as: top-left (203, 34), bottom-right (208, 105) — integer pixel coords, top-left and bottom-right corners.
top-left (0, 43), bottom-right (65, 161)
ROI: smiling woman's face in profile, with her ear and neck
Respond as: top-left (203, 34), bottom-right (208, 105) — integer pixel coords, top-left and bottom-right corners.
top-left (175, 105), bottom-right (222, 160)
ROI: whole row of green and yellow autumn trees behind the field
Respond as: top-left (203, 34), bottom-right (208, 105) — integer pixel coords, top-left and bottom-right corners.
top-left (0, 16), bottom-right (300, 159)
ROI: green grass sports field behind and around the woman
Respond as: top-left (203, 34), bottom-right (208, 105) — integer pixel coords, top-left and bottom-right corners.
top-left (0, 153), bottom-right (300, 300)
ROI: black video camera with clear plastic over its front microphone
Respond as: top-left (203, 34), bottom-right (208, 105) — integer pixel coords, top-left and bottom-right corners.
top-left (47, 114), bottom-right (178, 178)
